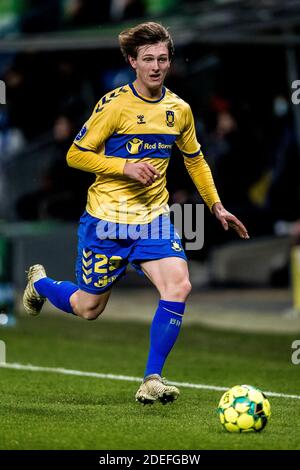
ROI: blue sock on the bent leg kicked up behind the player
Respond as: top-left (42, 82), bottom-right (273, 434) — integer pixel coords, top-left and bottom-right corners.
top-left (34, 277), bottom-right (79, 313)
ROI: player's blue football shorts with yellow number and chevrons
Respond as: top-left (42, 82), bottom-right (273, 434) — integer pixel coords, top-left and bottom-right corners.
top-left (76, 211), bottom-right (186, 294)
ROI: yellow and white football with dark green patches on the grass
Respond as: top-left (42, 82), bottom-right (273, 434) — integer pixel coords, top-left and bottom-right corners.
top-left (218, 385), bottom-right (271, 432)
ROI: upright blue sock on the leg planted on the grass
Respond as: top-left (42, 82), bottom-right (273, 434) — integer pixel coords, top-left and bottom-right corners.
top-left (145, 300), bottom-right (185, 377)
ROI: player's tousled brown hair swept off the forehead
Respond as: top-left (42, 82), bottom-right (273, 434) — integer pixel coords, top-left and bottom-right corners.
top-left (119, 21), bottom-right (174, 62)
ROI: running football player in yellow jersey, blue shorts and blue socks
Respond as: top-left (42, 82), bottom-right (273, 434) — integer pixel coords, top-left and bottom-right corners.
top-left (24, 22), bottom-right (249, 404)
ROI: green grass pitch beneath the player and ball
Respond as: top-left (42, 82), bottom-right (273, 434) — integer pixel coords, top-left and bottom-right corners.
top-left (0, 315), bottom-right (300, 450)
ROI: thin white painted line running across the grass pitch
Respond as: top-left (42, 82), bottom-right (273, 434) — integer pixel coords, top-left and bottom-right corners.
top-left (0, 363), bottom-right (300, 400)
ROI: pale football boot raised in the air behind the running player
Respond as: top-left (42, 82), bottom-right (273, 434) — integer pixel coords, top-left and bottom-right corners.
top-left (23, 264), bottom-right (47, 315)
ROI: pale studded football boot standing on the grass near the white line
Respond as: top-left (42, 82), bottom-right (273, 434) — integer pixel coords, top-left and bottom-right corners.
top-left (135, 374), bottom-right (179, 405)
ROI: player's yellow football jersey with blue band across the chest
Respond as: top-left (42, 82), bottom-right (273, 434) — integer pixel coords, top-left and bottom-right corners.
top-left (68, 84), bottom-right (219, 223)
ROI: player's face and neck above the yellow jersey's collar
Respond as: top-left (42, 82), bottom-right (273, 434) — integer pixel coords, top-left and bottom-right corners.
top-left (129, 42), bottom-right (170, 94)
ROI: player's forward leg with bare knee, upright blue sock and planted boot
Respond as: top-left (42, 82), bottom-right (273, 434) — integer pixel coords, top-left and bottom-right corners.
top-left (136, 257), bottom-right (191, 404)
